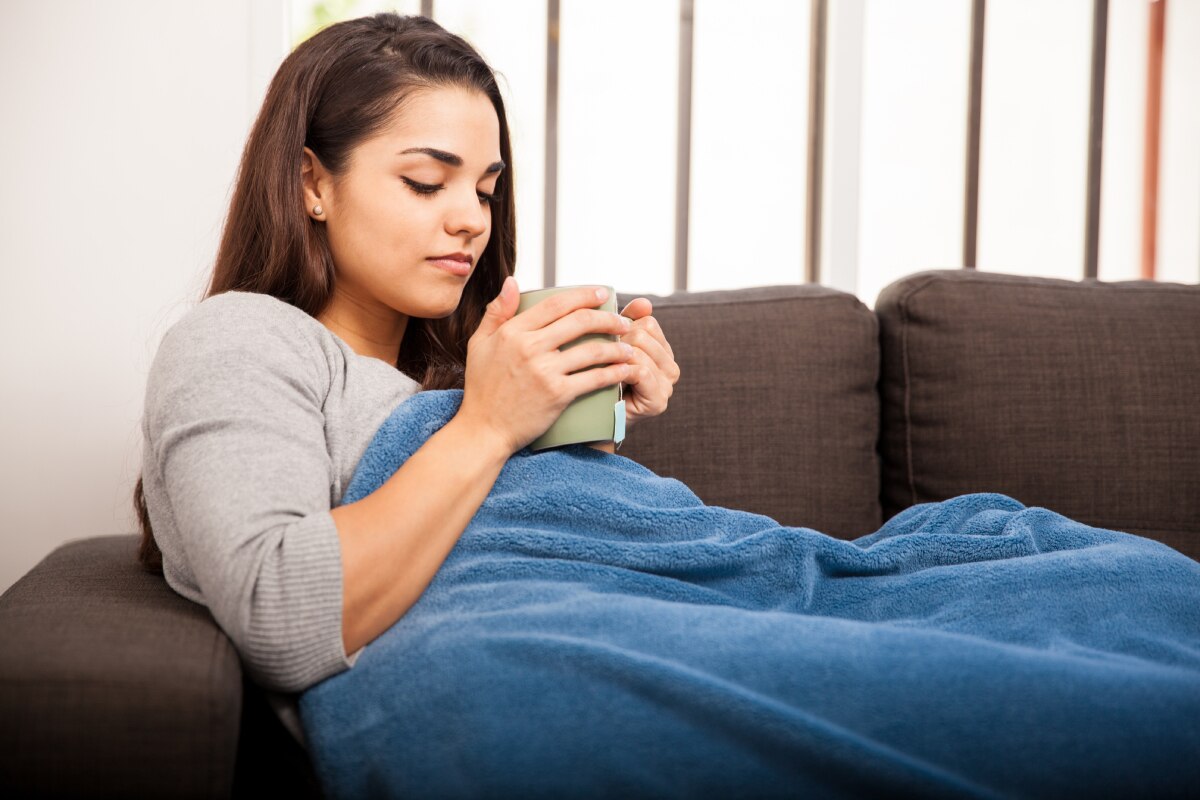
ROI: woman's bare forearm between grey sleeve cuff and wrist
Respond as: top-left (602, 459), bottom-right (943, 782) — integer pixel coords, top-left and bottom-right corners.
top-left (330, 417), bottom-right (511, 654)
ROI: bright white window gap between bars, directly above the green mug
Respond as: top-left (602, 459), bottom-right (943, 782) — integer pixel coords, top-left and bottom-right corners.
top-left (556, 0), bottom-right (679, 294)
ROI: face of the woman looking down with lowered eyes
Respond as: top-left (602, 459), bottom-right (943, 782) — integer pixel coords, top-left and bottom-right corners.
top-left (304, 88), bottom-right (504, 335)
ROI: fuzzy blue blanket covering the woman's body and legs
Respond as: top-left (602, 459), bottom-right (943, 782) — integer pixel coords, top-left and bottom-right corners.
top-left (300, 390), bottom-right (1200, 798)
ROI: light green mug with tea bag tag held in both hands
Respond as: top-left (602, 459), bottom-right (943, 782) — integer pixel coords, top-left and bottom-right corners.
top-left (516, 284), bottom-right (625, 451)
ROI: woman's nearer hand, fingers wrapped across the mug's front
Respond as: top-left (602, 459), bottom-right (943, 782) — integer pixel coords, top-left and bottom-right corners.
top-left (456, 276), bottom-right (631, 455)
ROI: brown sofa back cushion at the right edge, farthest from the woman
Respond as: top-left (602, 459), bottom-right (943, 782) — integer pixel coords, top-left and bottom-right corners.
top-left (875, 270), bottom-right (1200, 558)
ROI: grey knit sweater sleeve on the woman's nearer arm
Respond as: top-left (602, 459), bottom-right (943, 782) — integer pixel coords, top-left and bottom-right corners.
top-left (145, 296), bottom-right (353, 692)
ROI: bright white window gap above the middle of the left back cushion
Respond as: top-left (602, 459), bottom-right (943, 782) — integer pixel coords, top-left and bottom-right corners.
top-left (691, 0), bottom-right (811, 291)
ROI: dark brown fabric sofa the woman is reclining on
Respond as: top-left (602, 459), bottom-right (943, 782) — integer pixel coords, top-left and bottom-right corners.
top-left (0, 270), bottom-right (1200, 796)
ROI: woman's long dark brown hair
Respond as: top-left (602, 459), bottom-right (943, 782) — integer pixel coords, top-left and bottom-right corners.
top-left (133, 13), bottom-right (516, 572)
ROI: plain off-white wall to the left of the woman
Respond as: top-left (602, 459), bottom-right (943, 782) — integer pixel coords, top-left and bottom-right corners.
top-left (0, 0), bottom-right (284, 590)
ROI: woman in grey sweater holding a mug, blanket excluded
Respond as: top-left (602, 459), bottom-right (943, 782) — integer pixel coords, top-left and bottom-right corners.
top-left (134, 13), bottom-right (679, 692)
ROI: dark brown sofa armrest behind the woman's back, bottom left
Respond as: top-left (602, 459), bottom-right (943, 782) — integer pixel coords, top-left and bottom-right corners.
top-left (0, 535), bottom-right (242, 796)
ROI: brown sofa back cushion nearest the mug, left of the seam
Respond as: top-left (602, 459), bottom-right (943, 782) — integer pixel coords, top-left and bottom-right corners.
top-left (617, 284), bottom-right (881, 539)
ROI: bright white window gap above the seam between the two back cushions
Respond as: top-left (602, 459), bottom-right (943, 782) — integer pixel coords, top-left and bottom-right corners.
top-left (854, 0), bottom-right (974, 307)
